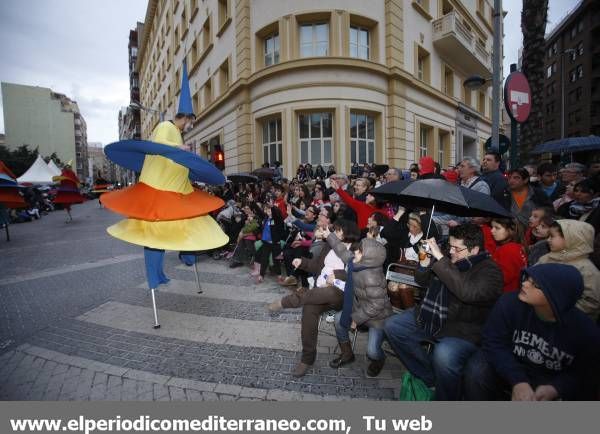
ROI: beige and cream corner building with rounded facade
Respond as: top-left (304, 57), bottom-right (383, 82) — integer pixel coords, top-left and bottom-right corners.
top-left (136, 0), bottom-right (493, 177)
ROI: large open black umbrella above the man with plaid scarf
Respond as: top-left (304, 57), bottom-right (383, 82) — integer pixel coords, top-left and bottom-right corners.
top-left (371, 179), bottom-right (512, 232)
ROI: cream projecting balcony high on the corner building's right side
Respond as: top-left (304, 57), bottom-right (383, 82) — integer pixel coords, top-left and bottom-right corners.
top-left (433, 11), bottom-right (492, 76)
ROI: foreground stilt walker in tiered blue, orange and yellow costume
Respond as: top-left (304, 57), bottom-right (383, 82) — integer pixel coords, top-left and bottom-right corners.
top-left (100, 61), bottom-right (229, 328)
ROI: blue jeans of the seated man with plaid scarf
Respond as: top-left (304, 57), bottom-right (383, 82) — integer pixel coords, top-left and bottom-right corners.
top-left (384, 308), bottom-right (477, 401)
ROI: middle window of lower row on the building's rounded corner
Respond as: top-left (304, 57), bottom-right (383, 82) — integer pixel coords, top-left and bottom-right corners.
top-left (298, 113), bottom-right (333, 165)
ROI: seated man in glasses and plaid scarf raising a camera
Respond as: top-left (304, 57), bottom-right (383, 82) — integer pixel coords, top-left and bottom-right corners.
top-left (384, 223), bottom-right (503, 401)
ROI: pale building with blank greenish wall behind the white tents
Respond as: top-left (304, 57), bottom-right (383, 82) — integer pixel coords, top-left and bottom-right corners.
top-left (2, 82), bottom-right (89, 182)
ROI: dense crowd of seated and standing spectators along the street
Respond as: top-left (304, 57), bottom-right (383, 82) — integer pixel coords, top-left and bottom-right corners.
top-left (202, 152), bottom-right (600, 400)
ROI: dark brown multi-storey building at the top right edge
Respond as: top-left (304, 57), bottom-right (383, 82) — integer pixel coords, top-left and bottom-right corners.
top-left (544, 0), bottom-right (600, 141)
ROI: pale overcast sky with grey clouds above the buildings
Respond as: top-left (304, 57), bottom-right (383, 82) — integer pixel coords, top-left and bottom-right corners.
top-left (0, 0), bottom-right (578, 144)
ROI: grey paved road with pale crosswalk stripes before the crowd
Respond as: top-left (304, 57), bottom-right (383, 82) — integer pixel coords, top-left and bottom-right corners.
top-left (0, 201), bottom-right (403, 400)
